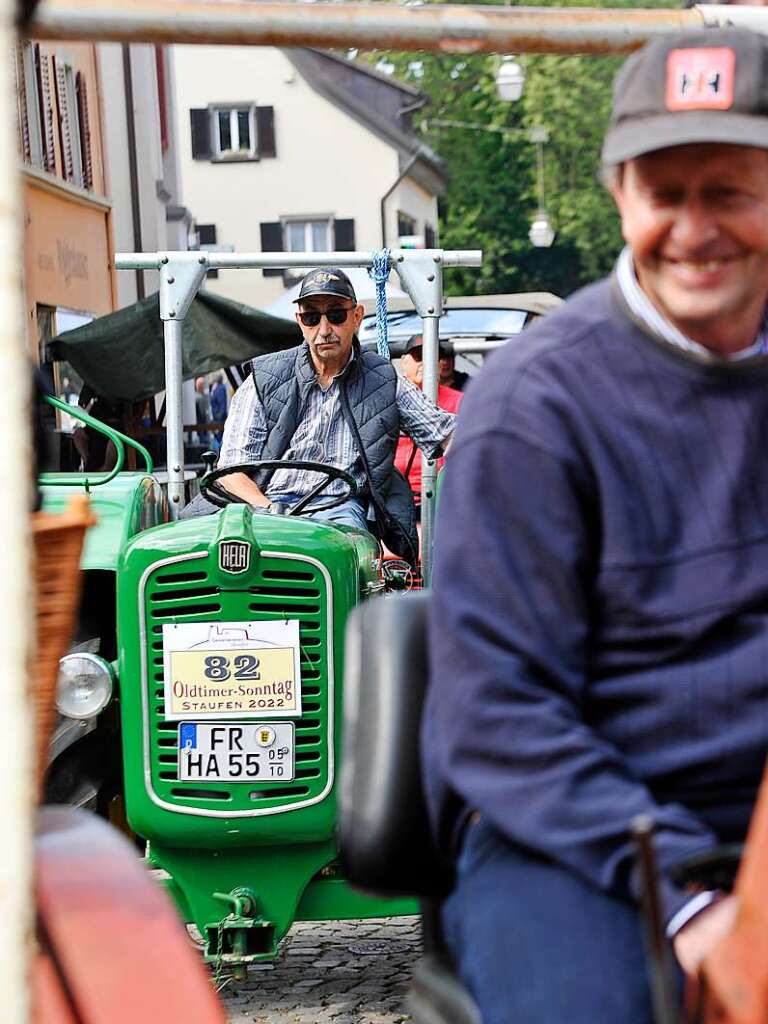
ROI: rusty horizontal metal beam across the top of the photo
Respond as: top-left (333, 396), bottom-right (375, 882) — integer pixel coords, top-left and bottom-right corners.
top-left (30, 0), bottom-right (720, 53)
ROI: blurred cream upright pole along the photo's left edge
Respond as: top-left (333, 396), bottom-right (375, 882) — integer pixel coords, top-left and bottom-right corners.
top-left (0, 0), bottom-right (34, 1024)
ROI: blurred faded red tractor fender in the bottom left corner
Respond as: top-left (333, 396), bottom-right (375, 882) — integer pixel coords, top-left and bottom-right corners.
top-left (33, 807), bottom-right (225, 1024)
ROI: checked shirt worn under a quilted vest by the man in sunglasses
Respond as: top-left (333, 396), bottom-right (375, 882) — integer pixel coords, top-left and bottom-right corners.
top-left (218, 356), bottom-right (456, 502)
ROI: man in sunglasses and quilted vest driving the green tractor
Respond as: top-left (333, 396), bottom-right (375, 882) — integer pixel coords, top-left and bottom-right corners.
top-left (219, 268), bottom-right (454, 562)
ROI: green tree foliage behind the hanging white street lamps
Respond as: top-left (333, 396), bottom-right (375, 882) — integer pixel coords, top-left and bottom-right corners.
top-left (367, 0), bottom-right (671, 295)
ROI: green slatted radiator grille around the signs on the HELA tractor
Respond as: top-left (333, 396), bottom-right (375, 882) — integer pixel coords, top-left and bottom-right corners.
top-left (144, 557), bottom-right (333, 812)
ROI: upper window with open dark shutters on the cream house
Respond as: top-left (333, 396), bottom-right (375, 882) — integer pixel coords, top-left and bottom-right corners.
top-left (189, 102), bottom-right (276, 163)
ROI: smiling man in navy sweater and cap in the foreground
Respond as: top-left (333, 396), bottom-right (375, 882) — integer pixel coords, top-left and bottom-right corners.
top-left (423, 30), bottom-right (768, 1024)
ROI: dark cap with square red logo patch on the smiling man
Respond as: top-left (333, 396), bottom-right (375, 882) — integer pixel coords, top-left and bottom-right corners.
top-left (602, 29), bottom-right (768, 166)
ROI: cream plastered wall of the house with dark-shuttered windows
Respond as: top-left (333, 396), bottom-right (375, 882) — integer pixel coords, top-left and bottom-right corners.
top-left (173, 46), bottom-right (436, 307)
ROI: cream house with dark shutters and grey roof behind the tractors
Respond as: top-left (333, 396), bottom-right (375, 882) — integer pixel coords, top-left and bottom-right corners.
top-left (169, 46), bottom-right (444, 308)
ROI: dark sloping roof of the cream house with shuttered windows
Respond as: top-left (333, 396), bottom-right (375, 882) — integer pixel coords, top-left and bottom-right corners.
top-left (283, 48), bottom-right (447, 196)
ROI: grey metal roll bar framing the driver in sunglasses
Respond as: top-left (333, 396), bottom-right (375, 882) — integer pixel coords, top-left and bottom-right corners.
top-left (115, 249), bottom-right (482, 583)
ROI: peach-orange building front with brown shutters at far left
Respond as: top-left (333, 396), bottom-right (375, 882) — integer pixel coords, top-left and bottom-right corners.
top-left (14, 41), bottom-right (117, 361)
